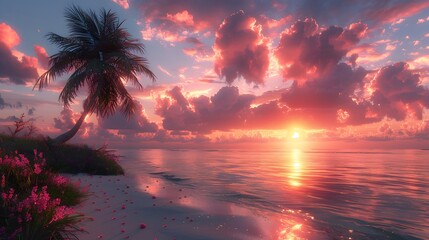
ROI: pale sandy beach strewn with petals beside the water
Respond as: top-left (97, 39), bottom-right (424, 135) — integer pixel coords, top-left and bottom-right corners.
top-left (71, 172), bottom-right (278, 240)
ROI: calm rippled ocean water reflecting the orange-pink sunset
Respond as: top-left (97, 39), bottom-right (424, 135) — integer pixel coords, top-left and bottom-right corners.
top-left (119, 149), bottom-right (429, 239)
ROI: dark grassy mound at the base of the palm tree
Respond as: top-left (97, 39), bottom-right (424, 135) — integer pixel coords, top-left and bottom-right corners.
top-left (0, 134), bottom-right (124, 175)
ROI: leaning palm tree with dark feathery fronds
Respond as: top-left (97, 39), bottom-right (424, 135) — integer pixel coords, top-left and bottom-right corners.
top-left (34, 6), bottom-right (156, 143)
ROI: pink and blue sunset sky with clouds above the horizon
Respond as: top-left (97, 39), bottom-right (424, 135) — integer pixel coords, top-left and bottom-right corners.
top-left (0, 0), bottom-right (429, 148)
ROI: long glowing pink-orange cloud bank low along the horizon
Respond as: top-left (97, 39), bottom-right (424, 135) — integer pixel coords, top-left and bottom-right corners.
top-left (135, 63), bottom-right (429, 134)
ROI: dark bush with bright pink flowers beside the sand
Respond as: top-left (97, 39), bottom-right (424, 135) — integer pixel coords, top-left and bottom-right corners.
top-left (0, 150), bottom-right (83, 240)
